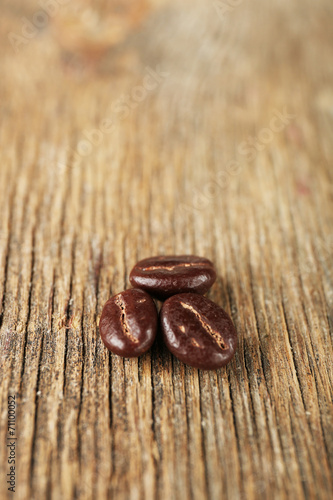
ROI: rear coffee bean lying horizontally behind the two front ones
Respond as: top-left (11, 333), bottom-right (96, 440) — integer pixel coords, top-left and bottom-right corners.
top-left (130, 255), bottom-right (216, 299)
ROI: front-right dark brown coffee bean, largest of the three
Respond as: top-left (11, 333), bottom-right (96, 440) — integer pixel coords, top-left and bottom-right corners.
top-left (161, 293), bottom-right (237, 370)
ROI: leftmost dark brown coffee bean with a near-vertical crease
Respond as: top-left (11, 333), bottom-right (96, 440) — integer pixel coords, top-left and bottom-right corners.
top-left (99, 288), bottom-right (158, 358)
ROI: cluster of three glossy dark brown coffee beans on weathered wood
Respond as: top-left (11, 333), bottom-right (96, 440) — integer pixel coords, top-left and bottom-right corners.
top-left (99, 255), bottom-right (237, 370)
